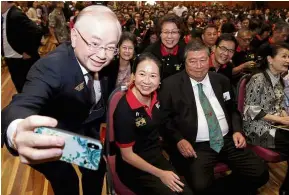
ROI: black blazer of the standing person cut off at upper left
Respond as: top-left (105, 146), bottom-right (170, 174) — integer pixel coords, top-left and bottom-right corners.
top-left (6, 6), bottom-right (43, 57)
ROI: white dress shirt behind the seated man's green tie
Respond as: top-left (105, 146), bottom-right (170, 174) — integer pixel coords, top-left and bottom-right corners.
top-left (190, 74), bottom-right (229, 142)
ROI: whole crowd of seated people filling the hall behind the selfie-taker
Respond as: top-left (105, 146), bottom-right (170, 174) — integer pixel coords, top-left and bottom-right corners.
top-left (2, 2), bottom-right (289, 195)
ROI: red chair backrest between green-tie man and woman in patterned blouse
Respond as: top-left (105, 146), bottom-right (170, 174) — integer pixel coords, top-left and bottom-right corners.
top-left (237, 74), bottom-right (251, 114)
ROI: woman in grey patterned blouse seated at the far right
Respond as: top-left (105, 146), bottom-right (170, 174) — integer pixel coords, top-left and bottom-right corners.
top-left (244, 43), bottom-right (289, 195)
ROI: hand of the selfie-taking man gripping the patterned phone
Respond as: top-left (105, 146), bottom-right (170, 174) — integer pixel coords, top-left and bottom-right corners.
top-left (13, 115), bottom-right (64, 164)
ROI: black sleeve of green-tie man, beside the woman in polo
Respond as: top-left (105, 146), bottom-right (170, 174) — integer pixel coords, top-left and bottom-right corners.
top-left (159, 80), bottom-right (184, 144)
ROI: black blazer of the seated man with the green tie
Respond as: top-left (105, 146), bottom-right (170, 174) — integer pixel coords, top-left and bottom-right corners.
top-left (159, 70), bottom-right (242, 147)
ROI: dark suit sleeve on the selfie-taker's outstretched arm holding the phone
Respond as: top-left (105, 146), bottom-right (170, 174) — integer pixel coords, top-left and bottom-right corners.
top-left (1, 59), bottom-right (61, 154)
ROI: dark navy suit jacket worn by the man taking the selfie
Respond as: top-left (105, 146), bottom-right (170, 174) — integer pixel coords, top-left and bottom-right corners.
top-left (2, 43), bottom-right (110, 153)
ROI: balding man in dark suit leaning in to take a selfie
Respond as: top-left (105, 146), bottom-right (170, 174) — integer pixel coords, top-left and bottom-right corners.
top-left (2, 6), bottom-right (121, 195)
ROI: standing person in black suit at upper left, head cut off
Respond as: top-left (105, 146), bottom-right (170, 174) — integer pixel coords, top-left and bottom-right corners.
top-left (1, 1), bottom-right (42, 93)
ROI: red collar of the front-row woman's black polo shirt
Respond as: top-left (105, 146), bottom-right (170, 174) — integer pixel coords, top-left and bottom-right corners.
top-left (126, 84), bottom-right (157, 109)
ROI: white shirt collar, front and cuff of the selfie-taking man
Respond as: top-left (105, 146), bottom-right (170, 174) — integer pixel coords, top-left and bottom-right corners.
top-left (7, 61), bottom-right (101, 148)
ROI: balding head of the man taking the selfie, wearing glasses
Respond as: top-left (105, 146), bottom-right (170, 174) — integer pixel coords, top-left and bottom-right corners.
top-left (71, 5), bottom-right (121, 72)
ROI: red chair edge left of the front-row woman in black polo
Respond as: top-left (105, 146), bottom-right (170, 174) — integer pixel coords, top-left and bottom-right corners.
top-left (106, 88), bottom-right (135, 195)
